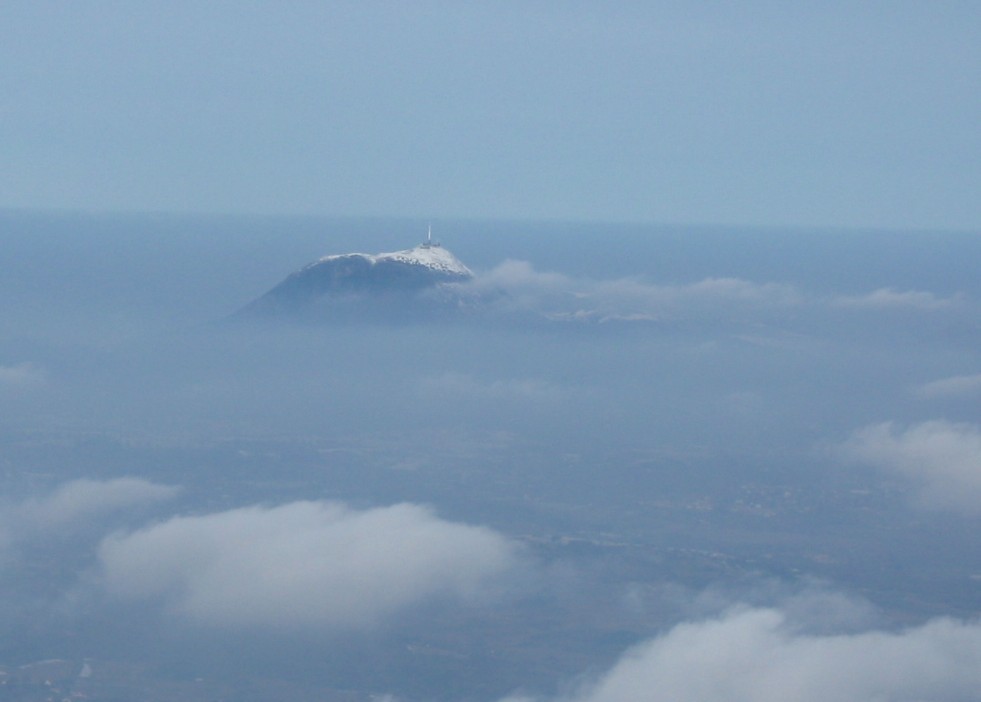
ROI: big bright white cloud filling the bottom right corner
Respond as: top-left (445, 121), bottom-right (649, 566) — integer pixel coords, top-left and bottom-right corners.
top-left (510, 608), bottom-right (981, 702)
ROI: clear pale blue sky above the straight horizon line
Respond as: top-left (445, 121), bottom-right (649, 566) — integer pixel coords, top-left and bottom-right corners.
top-left (0, 1), bottom-right (981, 230)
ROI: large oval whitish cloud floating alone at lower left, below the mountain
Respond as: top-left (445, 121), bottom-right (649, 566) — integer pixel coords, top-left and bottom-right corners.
top-left (99, 502), bottom-right (515, 629)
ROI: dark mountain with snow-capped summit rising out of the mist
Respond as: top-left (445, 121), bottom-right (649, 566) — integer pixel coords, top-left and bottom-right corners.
top-left (236, 242), bottom-right (473, 321)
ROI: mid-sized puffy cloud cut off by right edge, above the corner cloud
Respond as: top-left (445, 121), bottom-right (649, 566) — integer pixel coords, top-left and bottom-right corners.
top-left (844, 420), bottom-right (981, 515)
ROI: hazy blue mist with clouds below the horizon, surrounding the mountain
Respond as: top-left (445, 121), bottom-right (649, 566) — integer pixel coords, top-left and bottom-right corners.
top-left (0, 212), bottom-right (981, 700)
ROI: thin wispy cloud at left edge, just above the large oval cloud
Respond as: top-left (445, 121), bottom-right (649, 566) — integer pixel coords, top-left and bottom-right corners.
top-left (5, 478), bottom-right (180, 530)
